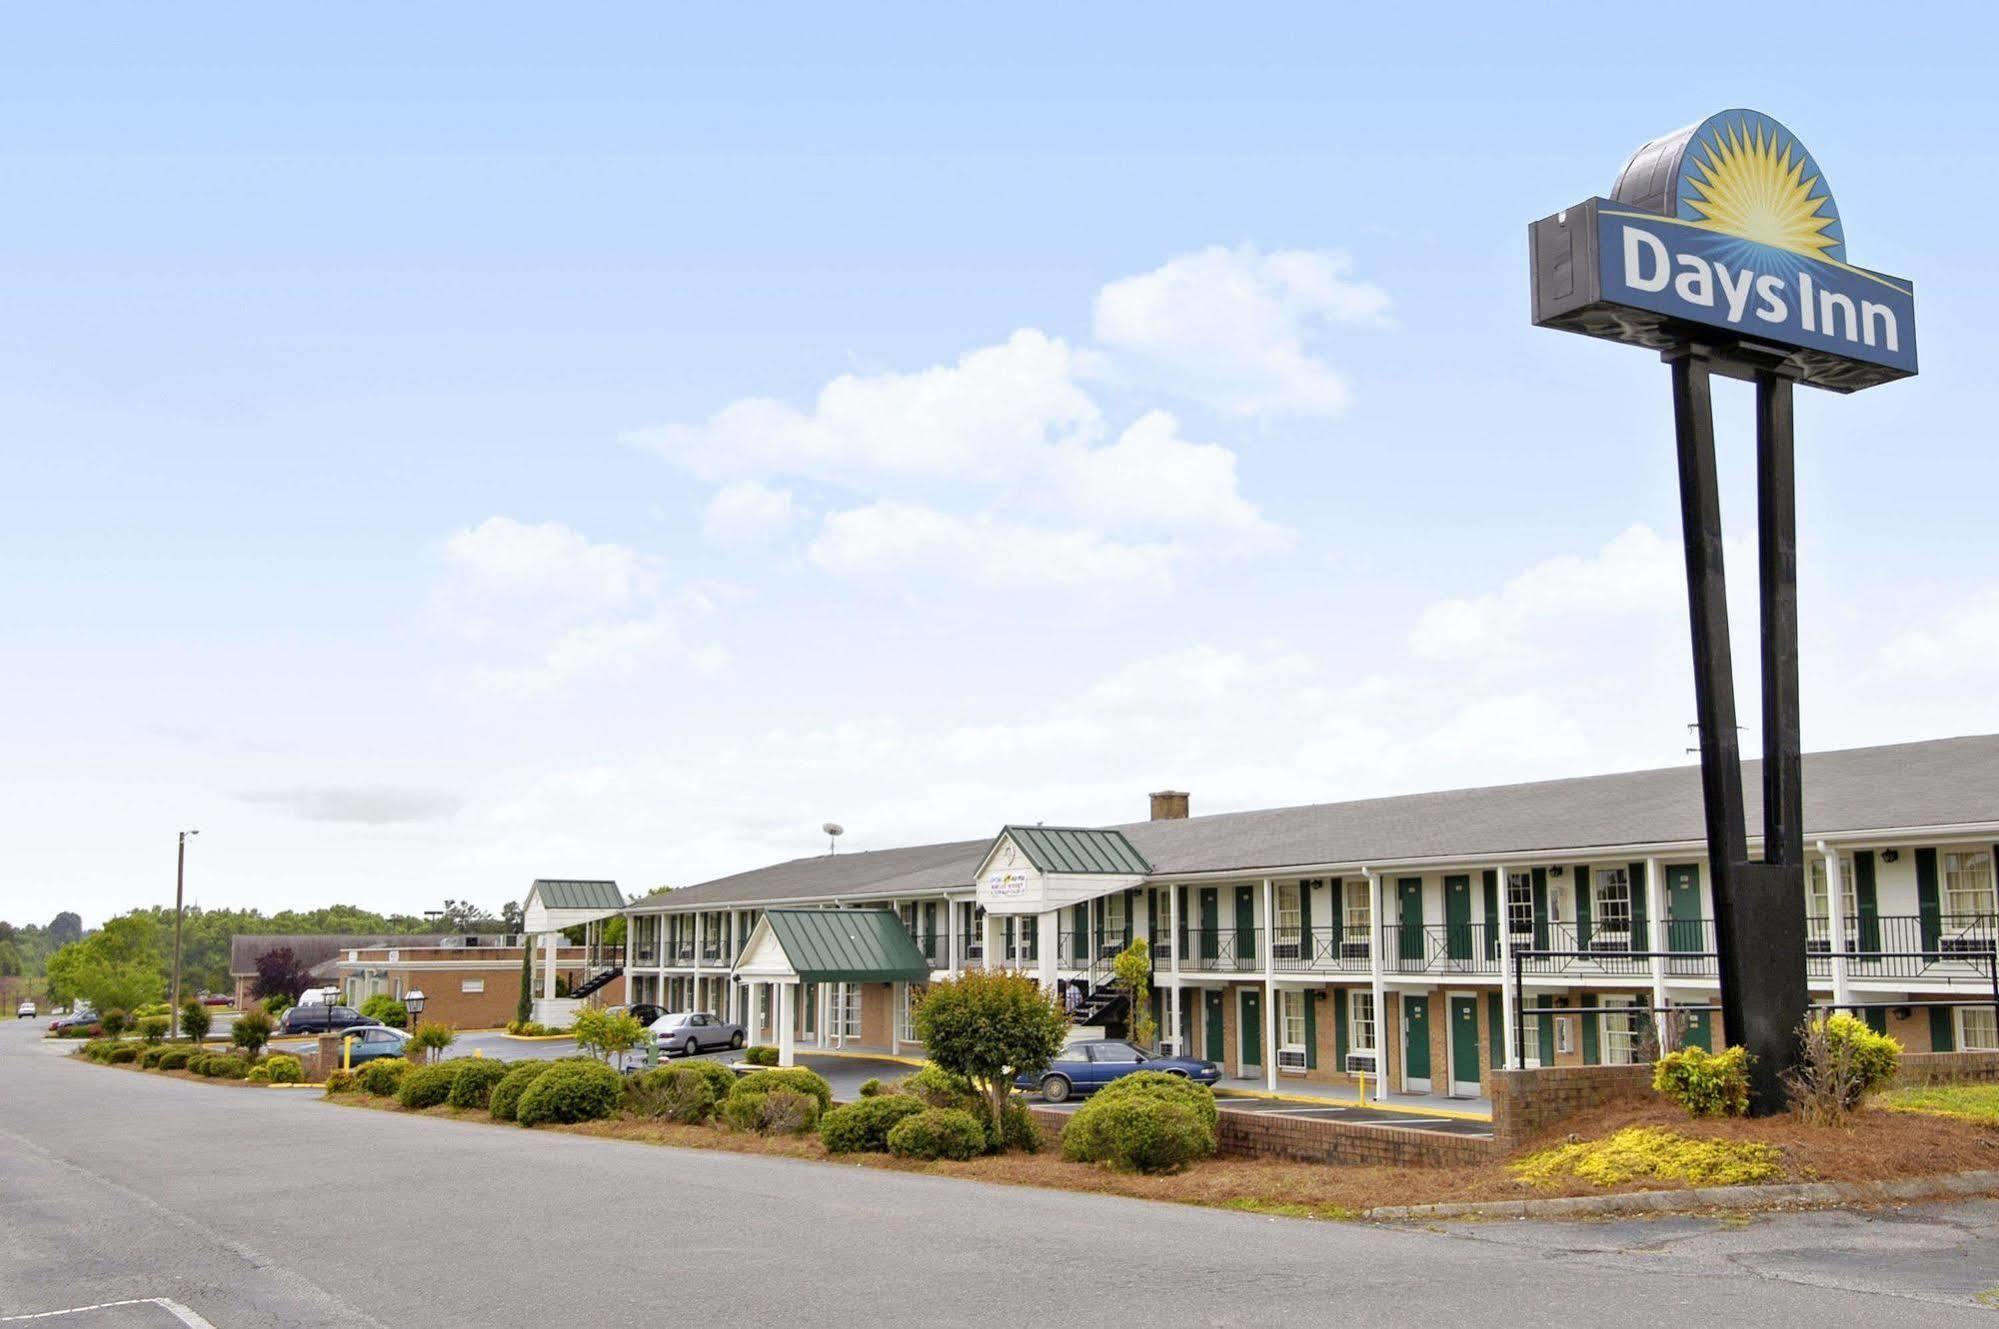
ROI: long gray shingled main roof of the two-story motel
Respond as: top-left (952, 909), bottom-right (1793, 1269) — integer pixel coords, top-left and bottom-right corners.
top-left (627, 733), bottom-right (1999, 909)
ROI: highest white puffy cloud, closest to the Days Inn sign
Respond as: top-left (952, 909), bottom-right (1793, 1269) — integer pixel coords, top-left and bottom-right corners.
top-left (1095, 246), bottom-right (1389, 416)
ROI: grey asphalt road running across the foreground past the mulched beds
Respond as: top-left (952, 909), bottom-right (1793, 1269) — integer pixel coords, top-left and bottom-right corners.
top-left (0, 1021), bottom-right (1999, 1329)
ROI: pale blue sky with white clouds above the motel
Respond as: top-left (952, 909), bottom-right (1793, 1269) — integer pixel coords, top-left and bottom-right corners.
top-left (0, 4), bottom-right (1999, 919)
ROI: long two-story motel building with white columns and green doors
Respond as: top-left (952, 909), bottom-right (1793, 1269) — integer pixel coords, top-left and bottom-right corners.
top-left (626, 735), bottom-right (1999, 1097)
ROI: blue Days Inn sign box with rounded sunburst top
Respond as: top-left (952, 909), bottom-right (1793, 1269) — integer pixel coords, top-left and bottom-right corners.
top-left (1529, 110), bottom-right (1915, 392)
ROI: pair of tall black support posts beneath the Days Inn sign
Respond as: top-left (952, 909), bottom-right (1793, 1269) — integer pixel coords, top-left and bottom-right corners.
top-left (1667, 346), bottom-right (1809, 1115)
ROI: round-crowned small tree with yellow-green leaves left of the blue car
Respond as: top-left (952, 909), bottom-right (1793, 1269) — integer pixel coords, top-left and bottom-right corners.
top-left (916, 969), bottom-right (1069, 1133)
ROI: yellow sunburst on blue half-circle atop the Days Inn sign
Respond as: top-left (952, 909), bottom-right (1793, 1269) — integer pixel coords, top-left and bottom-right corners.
top-left (1679, 112), bottom-right (1845, 262)
